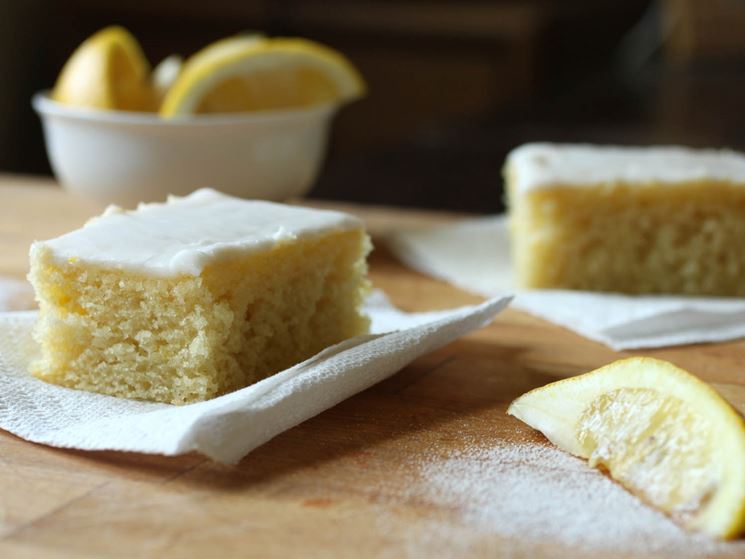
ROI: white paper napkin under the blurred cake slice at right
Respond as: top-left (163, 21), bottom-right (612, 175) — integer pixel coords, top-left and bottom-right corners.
top-left (387, 216), bottom-right (745, 349)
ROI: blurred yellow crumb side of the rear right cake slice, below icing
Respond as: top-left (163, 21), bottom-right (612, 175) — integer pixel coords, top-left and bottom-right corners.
top-left (510, 181), bottom-right (745, 296)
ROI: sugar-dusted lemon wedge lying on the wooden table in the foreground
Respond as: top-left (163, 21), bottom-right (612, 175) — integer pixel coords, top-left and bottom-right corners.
top-left (507, 357), bottom-right (745, 538)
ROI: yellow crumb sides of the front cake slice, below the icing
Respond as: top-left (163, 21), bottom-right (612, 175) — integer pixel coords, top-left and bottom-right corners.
top-left (29, 229), bottom-right (370, 404)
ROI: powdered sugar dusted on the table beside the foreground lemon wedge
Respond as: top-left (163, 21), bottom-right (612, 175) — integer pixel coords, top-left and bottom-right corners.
top-left (384, 442), bottom-right (745, 558)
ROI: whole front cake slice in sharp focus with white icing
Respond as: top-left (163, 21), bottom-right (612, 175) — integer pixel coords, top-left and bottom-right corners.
top-left (29, 189), bottom-right (371, 404)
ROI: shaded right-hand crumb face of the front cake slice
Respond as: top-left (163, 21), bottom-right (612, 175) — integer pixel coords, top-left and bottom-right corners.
top-left (203, 226), bottom-right (372, 386)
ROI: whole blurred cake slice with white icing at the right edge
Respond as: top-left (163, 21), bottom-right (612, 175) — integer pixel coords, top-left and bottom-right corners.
top-left (505, 144), bottom-right (745, 296)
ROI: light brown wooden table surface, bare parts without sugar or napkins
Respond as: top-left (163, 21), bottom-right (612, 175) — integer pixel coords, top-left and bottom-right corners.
top-left (0, 176), bottom-right (745, 558)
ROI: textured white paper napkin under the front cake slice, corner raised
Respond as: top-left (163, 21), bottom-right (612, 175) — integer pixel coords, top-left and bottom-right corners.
top-left (0, 292), bottom-right (509, 463)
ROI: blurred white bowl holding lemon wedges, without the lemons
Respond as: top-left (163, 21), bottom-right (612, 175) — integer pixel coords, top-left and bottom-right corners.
top-left (33, 93), bottom-right (337, 207)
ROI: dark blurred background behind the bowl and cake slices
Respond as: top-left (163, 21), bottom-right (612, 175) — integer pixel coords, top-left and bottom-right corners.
top-left (0, 0), bottom-right (745, 212)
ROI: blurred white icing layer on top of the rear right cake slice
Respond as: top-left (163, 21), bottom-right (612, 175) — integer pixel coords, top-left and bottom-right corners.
top-left (507, 143), bottom-right (745, 194)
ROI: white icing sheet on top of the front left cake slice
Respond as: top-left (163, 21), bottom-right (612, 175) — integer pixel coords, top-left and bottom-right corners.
top-left (31, 188), bottom-right (362, 277)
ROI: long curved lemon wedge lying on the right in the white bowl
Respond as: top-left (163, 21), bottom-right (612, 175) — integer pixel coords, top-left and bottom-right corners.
top-left (160, 37), bottom-right (365, 118)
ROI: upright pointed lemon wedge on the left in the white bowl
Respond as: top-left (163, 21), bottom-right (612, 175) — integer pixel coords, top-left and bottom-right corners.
top-left (52, 26), bottom-right (155, 111)
